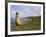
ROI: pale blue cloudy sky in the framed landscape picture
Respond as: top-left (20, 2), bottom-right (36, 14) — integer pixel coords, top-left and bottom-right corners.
top-left (10, 5), bottom-right (41, 18)
